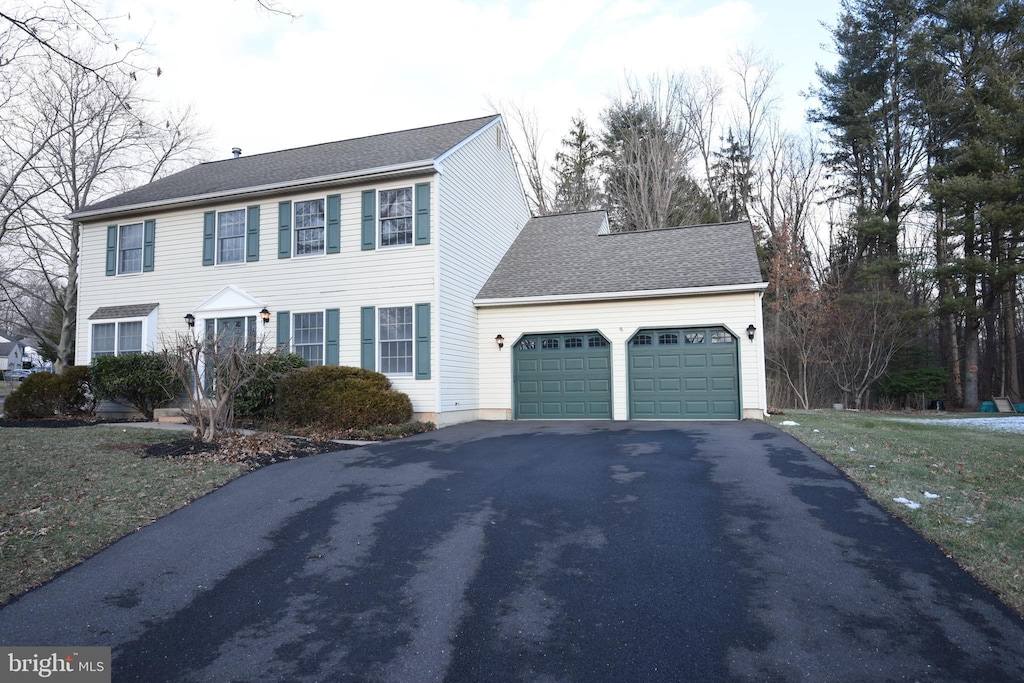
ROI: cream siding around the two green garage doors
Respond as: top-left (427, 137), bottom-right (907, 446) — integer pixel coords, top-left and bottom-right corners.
top-left (478, 292), bottom-right (767, 420)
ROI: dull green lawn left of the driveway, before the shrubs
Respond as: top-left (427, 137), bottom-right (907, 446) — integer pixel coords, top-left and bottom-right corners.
top-left (0, 425), bottom-right (246, 604)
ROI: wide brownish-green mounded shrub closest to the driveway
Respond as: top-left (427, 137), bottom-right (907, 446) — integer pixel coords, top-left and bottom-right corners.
top-left (278, 366), bottom-right (413, 429)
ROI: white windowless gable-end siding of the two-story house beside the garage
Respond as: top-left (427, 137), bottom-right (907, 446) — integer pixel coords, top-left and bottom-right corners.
top-left (437, 122), bottom-right (529, 422)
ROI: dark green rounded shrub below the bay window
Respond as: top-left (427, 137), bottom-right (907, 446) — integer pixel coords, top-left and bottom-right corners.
top-left (92, 353), bottom-right (184, 420)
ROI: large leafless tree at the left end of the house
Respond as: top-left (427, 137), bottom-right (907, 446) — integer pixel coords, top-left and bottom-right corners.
top-left (0, 46), bottom-right (204, 371)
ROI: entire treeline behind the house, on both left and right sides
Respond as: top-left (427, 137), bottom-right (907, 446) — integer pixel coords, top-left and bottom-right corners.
top-left (0, 0), bottom-right (1024, 409)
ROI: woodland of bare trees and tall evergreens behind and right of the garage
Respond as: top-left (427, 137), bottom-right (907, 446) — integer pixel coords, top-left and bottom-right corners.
top-left (507, 0), bottom-right (1024, 409)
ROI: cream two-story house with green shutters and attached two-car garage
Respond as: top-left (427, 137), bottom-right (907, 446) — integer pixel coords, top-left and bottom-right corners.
top-left (71, 116), bottom-right (766, 425)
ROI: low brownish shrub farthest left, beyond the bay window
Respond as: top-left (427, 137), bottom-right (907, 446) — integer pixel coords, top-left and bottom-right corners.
top-left (4, 366), bottom-right (95, 420)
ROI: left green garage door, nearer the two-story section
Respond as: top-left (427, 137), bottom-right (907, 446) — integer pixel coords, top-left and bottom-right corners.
top-left (512, 332), bottom-right (611, 420)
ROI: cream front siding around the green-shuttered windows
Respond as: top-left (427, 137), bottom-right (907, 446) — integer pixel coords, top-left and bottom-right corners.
top-left (76, 175), bottom-right (438, 414)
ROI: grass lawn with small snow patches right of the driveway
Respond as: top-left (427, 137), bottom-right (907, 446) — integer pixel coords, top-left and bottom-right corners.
top-left (771, 411), bottom-right (1024, 615)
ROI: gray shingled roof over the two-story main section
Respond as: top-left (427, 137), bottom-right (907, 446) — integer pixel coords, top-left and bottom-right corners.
top-left (71, 115), bottom-right (497, 218)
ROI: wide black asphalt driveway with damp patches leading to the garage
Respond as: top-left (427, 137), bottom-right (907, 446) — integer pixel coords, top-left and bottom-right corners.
top-left (0, 422), bottom-right (1024, 682)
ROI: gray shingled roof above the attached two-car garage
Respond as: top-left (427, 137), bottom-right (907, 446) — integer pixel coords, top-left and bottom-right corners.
top-left (477, 211), bottom-right (763, 302)
